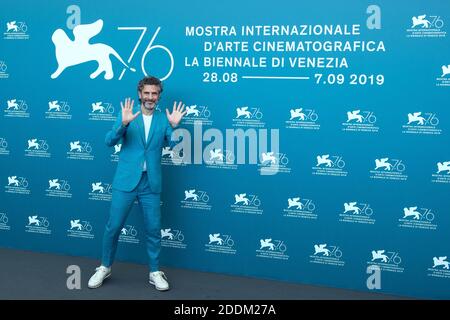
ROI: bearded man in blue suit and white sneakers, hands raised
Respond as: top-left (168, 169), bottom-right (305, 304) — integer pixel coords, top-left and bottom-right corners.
top-left (88, 77), bottom-right (186, 291)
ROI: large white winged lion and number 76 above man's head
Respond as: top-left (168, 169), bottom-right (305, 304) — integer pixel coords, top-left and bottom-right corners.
top-left (51, 19), bottom-right (174, 81)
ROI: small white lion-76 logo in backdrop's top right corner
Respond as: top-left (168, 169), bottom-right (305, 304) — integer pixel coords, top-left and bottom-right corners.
top-left (406, 13), bottom-right (447, 38)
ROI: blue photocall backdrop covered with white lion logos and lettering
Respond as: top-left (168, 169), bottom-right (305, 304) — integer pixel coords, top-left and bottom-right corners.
top-left (0, 0), bottom-right (450, 299)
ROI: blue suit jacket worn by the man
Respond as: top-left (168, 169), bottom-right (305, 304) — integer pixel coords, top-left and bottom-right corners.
top-left (105, 105), bottom-right (173, 193)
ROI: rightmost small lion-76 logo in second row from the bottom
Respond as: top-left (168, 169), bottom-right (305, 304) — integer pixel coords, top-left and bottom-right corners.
top-left (398, 206), bottom-right (437, 230)
